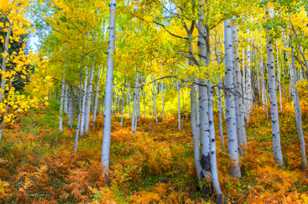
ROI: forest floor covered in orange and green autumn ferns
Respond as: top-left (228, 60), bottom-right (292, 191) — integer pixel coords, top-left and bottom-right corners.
top-left (0, 100), bottom-right (308, 204)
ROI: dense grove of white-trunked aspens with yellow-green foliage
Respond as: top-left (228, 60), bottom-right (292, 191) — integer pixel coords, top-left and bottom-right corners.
top-left (0, 0), bottom-right (308, 203)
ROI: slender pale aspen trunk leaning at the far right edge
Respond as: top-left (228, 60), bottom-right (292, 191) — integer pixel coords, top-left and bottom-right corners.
top-left (290, 47), bottom-right (307, 169)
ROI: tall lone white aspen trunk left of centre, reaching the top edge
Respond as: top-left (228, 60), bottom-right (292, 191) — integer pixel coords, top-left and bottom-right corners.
top-left (101, 0), bottom-right (116, 184)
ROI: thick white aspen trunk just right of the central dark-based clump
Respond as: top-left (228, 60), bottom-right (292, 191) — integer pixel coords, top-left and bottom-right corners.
top-left (224, 19), bottom-right (241, 177)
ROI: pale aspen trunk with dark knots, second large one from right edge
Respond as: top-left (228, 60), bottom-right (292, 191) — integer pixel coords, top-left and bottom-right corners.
top-left (266, 26), bottom-right (283, 166)
